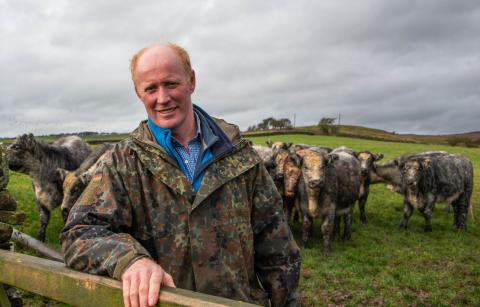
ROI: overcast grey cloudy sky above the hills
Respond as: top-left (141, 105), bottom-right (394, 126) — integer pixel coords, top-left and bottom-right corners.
top-left (0, 0), bottom-right (480, 137)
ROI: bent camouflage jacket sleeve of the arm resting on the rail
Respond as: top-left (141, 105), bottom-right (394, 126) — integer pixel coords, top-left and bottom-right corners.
top-left (61, 159), bottom-right (150, 279)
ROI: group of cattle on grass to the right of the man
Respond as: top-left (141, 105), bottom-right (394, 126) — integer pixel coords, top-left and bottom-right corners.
top-left (253, 142), bottom-right (473, 254)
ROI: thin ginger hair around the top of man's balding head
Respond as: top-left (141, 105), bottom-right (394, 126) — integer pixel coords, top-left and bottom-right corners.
top-left (130, 43), bottom-right (194, 95)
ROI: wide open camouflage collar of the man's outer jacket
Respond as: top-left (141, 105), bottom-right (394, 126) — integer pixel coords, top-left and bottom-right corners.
top-left (125, 106), bottom-right (260, 208)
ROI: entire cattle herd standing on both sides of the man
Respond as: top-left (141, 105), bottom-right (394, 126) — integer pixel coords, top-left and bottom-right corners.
top-left (3, 134), bottom-right (473, 254)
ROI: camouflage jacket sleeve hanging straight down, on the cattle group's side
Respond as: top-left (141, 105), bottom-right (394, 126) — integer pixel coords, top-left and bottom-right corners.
top-left (252, 164), bottom-right (300, 306)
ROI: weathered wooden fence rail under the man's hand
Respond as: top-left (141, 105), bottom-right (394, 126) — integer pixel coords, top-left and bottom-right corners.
top-left (0, 250), bottom-right (255, 307)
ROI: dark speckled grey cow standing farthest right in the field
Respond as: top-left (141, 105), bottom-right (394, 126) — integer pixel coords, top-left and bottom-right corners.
top-left (395, 154), bottom-right (473, 232)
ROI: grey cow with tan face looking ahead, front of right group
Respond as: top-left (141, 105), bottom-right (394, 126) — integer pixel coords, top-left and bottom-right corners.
top-left (293, 149), bottom-right (360, 255)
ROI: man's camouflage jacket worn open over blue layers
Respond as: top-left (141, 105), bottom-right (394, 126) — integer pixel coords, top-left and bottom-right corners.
top-left (61, 121), bottom-right (300, 306)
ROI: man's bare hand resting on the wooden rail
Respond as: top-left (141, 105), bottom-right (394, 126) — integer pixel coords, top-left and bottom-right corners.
top-left (122, 258), bottom-right (175, 307)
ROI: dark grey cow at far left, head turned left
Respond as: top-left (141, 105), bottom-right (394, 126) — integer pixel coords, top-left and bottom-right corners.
top-left (8, 133), bottom-right (91, 241)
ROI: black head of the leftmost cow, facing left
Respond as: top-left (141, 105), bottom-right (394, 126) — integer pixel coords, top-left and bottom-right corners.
top-left (7, 133), bottom-right (37, 173)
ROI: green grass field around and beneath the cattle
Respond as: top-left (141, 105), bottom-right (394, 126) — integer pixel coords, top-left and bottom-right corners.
top-left (4, 135), bottom-right (480, 306)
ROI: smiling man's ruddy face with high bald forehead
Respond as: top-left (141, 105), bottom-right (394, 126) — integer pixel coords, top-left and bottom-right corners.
top-left (135, 46), bottom-right (195, 135)
